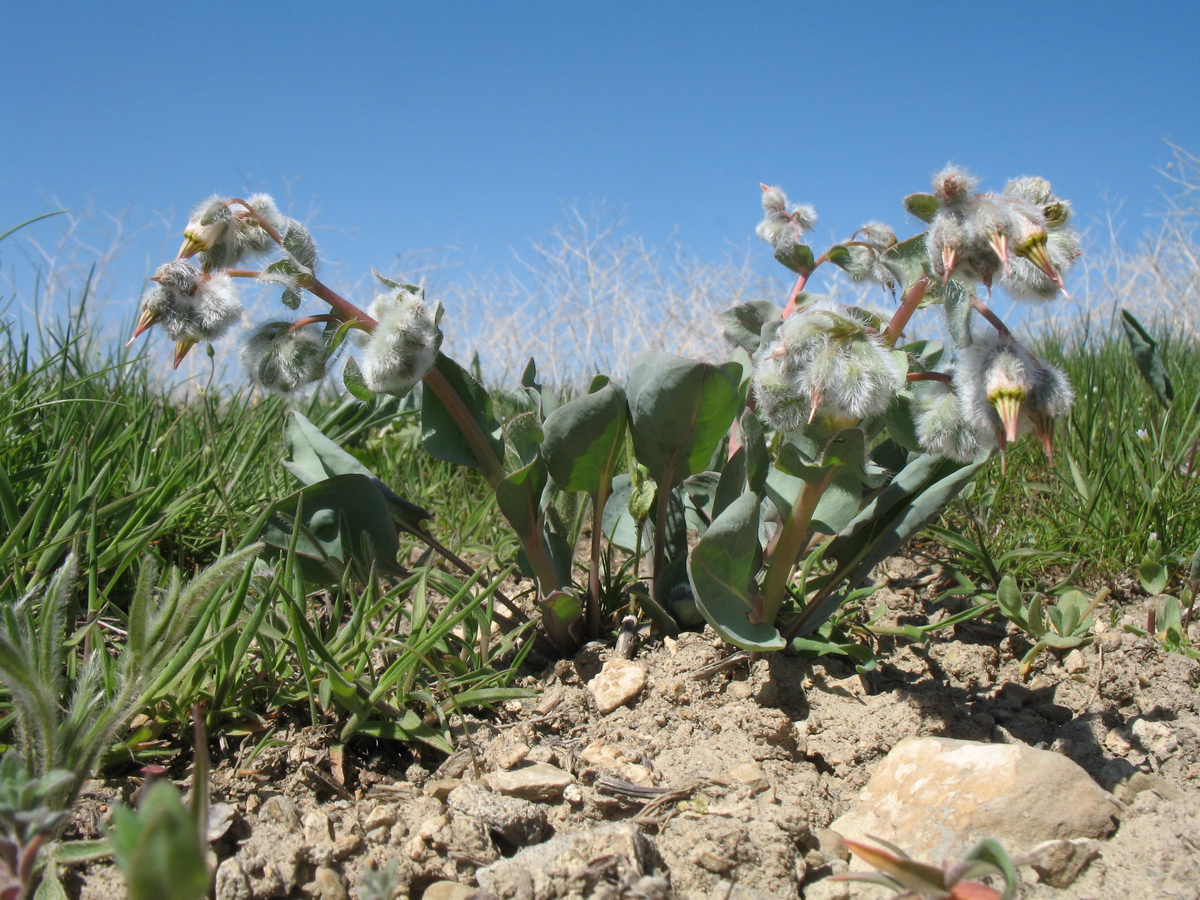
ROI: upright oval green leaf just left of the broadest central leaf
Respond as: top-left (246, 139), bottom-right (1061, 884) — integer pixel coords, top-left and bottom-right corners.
top-left (541, 383), bottom-right (629, 493)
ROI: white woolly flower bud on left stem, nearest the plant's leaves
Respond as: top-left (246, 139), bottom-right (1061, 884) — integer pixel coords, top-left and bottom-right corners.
top-left (360, 287), bottom-right (442, 395)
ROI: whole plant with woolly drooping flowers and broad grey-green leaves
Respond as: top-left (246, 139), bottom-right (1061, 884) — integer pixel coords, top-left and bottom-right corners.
top-left (134, 167), bottom-right (1079, 653)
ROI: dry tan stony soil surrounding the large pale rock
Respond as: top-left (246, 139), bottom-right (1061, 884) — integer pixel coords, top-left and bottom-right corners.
top-left (70, 558), bottom-right (1200, 900)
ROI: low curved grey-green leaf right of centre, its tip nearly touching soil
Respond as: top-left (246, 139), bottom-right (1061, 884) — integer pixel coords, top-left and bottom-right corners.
top-left (688, 492), bottom-right (786, 650)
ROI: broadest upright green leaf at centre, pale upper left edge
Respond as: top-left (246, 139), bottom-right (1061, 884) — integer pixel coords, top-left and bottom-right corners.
top-left (629, 353), bottom-right (742, 490)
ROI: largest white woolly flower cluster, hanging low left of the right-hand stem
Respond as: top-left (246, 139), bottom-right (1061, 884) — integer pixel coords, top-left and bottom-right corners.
top-left (755, 300), bottom-right (905, 431)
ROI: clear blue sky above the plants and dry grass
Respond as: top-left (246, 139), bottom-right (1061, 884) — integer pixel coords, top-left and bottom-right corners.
top-left (0, 0), bottom-right (1200, 331)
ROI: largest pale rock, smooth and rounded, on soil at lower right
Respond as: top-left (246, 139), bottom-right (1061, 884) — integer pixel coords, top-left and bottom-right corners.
top-left (830, 737), bottom-right (1121, 868)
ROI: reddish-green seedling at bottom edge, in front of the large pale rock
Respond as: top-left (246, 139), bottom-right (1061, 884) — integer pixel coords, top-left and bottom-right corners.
top-left (830, 838), bottom-right (1018, 900)
